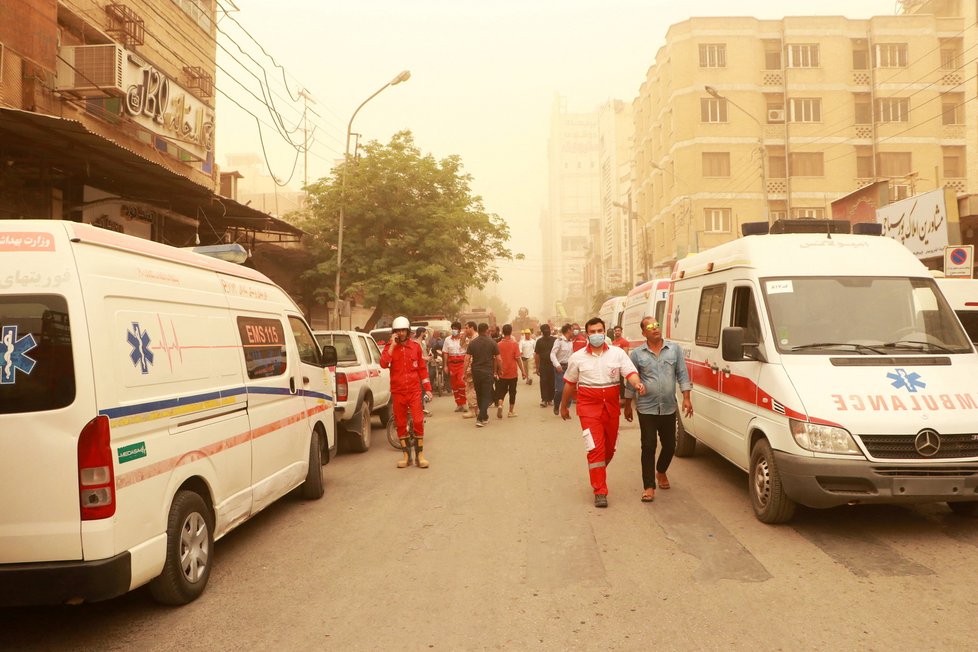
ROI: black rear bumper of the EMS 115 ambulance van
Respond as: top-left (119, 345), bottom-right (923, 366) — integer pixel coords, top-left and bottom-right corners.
top-left (0, 551), bottom-right (132, 607)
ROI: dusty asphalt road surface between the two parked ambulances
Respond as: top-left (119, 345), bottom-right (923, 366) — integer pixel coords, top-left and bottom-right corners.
top-left (0, 385), bottom-right (978, 651)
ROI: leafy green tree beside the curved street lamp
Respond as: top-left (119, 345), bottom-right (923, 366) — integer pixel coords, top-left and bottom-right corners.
top-left (302, 131), bottom-right (513, 330)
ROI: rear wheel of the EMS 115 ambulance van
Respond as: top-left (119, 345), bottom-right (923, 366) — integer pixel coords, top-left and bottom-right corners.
top-left (149, 490), bottom-right (214, 605)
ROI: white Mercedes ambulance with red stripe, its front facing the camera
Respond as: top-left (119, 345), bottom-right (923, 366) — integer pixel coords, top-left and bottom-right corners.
top-left (666, 227), bottom-right (978, 523)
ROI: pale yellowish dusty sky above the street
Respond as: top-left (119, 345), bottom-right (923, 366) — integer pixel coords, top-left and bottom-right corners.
top-left (217, 0), bottom-right (896, 316)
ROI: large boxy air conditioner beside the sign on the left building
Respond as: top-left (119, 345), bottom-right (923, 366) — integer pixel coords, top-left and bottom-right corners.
top-left (55, 43), bottom-right (126, 97)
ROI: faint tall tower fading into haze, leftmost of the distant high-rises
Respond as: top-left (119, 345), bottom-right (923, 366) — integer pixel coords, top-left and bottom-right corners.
top-left (540, 96), bottom-right (601, 318)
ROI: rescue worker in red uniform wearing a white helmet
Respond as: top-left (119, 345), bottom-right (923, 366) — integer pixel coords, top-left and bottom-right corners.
top-left (380, 317), bottom-right (431, 469)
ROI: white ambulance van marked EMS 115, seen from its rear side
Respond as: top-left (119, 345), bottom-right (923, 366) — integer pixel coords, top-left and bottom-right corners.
top-left (0, 220), bottom-right (336, 605)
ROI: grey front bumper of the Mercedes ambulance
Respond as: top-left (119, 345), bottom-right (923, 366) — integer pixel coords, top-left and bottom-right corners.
top-left (774, 451), bottom-right (978, 508)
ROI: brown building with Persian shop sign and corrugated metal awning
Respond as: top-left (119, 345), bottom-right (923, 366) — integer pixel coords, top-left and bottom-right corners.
top-left (0, 0), bottom-right (301, 287)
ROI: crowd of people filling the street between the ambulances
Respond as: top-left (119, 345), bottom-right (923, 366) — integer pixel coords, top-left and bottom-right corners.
top-left (381, 316), bottom-right (693, 507)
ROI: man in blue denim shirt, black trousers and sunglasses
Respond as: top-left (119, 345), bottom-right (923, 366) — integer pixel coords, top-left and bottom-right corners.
top-left (625, 317), bottom-right (693, 503)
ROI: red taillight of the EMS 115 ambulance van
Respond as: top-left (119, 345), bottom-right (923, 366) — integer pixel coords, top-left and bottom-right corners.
top-left (78, 416), bottom-right (115, 521)
